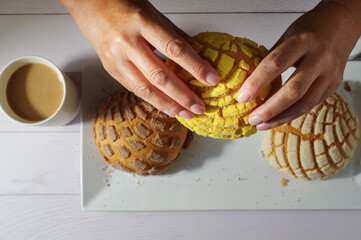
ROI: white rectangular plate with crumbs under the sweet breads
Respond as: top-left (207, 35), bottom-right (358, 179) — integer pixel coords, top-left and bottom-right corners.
top-left (81, 62), bottom-right (361, 211)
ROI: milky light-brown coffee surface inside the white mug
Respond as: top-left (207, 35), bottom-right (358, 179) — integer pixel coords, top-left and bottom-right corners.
top-left (6, 63), bottom-right (64, 122)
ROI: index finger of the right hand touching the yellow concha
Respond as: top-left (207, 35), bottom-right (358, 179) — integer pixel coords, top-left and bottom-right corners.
top-left (237, 38), bottom-right (307, 103)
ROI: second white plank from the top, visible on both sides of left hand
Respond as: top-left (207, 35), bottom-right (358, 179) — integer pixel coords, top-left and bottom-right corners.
top-left (0, 13), bottom-right (300, 72)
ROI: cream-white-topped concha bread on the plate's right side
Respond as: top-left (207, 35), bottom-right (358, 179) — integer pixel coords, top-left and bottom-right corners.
top-left (262, 93), bottom-right (360, 180)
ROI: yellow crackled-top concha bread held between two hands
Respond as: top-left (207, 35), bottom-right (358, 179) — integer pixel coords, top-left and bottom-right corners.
top-left (168, 32), bottom-right (281, 139)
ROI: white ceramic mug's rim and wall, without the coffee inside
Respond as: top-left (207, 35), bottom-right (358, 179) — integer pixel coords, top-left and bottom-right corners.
top-left (0, 56), bottom-right (80, 126)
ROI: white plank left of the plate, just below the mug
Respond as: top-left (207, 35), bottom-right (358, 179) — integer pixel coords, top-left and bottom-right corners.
top-left (0, 132), bottom-right (80, 195)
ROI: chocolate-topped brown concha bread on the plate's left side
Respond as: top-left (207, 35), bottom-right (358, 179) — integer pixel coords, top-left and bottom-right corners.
top-left (92, 89), bottom-right (188, 175)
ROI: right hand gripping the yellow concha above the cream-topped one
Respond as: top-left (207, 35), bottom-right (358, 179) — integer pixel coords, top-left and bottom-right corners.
top-left (238, 0), bottom-right (361, 130)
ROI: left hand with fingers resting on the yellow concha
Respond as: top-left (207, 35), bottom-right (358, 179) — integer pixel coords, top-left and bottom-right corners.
top-left (59, 0), bottom-right (219, 118)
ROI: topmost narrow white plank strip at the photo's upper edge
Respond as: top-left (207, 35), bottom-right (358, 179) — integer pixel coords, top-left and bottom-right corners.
top-left (0, 0), bottom-right (319, 14)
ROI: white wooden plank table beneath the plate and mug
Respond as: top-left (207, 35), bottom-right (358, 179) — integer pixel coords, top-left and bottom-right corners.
top-left (0, 0), bottom-right (361, 240)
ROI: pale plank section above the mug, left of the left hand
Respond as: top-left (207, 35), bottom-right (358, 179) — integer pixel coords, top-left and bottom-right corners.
top-left (0, 15), bottom-right (99, 72)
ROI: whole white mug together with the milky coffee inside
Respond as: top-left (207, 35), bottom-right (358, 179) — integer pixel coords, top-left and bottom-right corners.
top-left (0, 56), bottom-right (80, 126)
